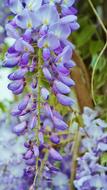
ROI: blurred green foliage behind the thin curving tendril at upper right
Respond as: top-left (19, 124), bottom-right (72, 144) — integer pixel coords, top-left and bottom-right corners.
top-left (72, 0), bottom-right (107, 120)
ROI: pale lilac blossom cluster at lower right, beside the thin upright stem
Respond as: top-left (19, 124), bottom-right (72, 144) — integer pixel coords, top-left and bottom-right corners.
top-left (74, 108), bottom-right (107, 190)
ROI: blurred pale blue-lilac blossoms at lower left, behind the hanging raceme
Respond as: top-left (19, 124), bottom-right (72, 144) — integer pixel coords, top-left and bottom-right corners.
top-left (0, 113), bottom-right (28, 190)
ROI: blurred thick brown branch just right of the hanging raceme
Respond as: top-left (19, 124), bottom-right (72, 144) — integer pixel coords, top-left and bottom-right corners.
top-left (71, 51), bottom-right (93, 112)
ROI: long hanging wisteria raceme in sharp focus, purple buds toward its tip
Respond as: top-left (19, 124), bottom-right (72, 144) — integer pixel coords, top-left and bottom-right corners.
top-left (3, 0), bottom-right (79, 187)
